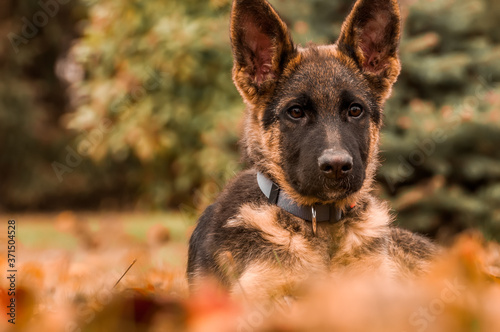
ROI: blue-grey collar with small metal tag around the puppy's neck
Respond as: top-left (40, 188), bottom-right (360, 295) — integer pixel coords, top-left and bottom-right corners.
top-left (257, 172), bottom-right (343, 233)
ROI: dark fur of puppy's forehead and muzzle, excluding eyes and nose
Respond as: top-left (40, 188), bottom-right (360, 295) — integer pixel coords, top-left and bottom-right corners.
top-left (274, 55), bottom-right (380, 201)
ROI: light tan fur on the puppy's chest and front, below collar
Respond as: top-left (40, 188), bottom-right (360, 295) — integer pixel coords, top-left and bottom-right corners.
top-left (219, 192), bottom-right (435, 300)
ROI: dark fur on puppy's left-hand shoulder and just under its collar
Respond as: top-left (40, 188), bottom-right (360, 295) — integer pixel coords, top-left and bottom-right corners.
top-left (187, 169), bottom-right (333, 286)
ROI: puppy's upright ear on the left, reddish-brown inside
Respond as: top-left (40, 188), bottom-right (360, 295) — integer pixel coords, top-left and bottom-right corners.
top-left (231, 0), bottom-right (294, 103)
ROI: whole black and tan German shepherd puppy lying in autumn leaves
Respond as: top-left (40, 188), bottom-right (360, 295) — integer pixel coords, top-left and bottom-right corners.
top-left (187, 0), bottom-right (435, 299)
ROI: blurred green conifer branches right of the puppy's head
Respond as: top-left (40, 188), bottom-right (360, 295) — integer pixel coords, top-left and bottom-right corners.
top-left (379, 0), bottom-right (500, 239)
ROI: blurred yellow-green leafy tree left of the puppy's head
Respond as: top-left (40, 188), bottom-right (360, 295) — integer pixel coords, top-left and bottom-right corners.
top-left (68, 0), bottom-right (243, 206)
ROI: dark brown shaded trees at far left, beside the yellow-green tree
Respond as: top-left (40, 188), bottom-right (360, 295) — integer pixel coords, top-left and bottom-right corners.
top-left (0, 0), bottom-right (146, 211)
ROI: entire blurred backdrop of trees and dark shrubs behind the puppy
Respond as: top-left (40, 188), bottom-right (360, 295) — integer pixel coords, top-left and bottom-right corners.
top-left (0, 0), bottom-right (500, 243)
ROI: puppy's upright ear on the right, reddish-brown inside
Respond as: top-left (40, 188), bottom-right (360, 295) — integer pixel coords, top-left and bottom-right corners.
top-left (337, 0), bottom-right (401, 97)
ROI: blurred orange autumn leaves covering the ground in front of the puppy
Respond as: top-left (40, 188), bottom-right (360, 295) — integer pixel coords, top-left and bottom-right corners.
top-left (0, 212), bottom-right (500, 332)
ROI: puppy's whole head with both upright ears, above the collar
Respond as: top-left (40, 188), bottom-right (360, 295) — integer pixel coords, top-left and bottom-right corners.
top-left (231, 0), bottom-right (400, 205)
